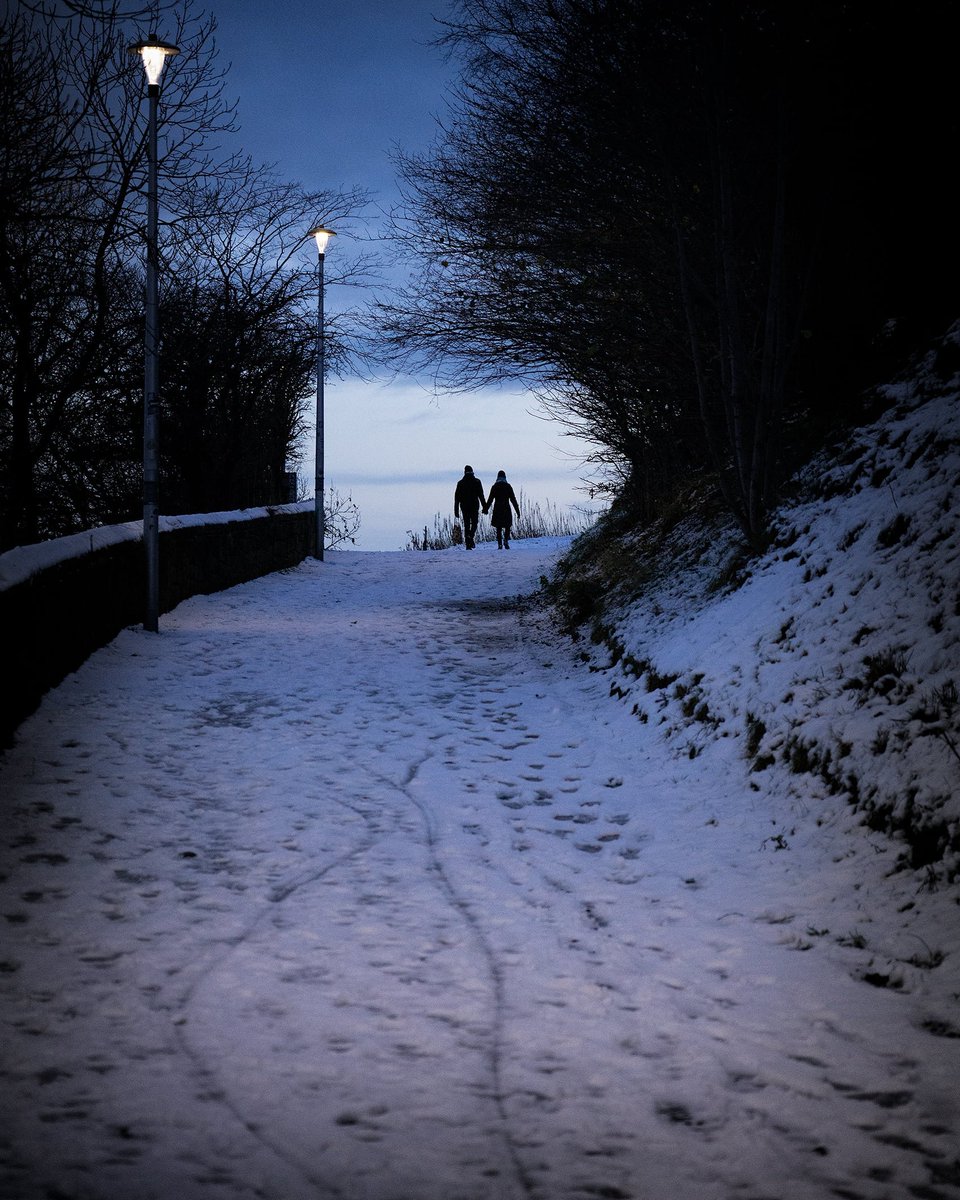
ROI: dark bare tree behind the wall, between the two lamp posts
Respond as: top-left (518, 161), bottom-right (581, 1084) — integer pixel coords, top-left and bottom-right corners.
top-left (162, 170), bottom-right (366, 512)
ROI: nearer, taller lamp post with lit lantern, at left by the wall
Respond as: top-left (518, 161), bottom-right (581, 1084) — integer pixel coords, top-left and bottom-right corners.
top-left (130, 34), bottom-right (180, 634)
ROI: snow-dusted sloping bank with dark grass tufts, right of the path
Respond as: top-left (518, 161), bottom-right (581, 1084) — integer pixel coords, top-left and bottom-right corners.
top-left (580, 348), bottom-right (960, 887)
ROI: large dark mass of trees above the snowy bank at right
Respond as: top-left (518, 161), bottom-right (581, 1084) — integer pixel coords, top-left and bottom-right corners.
top-left (383, 0), bottom-right (960, 542)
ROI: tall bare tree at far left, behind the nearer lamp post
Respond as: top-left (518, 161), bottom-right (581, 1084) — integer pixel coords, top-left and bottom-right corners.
top-left (0, 7), bottom-right (240, 545)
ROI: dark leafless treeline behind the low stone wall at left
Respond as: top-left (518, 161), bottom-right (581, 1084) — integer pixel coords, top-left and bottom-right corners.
top-left (0, 0), bottom-right (362, 550)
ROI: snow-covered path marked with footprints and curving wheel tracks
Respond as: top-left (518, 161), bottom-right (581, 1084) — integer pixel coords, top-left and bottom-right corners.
top-left (0, 542), bottom-right (960, 1200)
